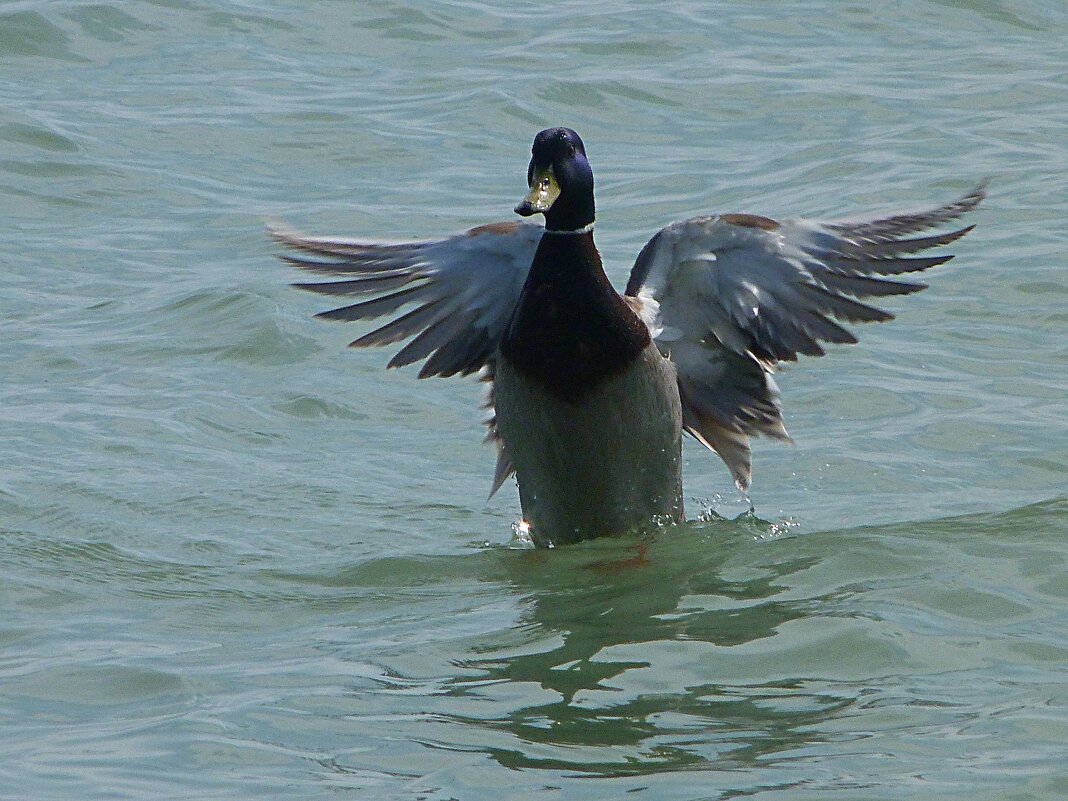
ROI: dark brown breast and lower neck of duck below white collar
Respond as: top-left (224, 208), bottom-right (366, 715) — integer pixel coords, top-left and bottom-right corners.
top-left (501, 230), bottom-right (649, 402)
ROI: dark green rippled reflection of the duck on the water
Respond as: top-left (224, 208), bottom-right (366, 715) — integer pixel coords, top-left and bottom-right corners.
top-left (429, 517), bottom-right (852, 776)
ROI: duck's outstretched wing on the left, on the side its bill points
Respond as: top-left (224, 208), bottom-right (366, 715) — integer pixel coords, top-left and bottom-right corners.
top-left (270, 216), bottom-right (544, 496)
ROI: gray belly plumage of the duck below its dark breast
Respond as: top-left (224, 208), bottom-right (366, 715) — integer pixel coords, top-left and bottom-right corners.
top-left (493, 344), bottom-right (682, 545)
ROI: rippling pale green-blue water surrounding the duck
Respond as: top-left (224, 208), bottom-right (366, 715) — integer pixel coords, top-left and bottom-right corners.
top-left (0, 0), bottom-right (1068, 801)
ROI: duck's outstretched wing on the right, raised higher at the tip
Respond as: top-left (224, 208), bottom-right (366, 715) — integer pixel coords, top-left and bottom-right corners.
top-left (626, 186), bottom-right (986, 490)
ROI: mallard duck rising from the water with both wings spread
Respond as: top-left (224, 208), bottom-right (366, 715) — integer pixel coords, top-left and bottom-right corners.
top-left (270, 127), bottom-right (986, 547)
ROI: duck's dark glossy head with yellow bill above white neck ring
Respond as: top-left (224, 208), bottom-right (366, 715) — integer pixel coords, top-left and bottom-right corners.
top-left (516, 128), bottom-right (594, 231)
